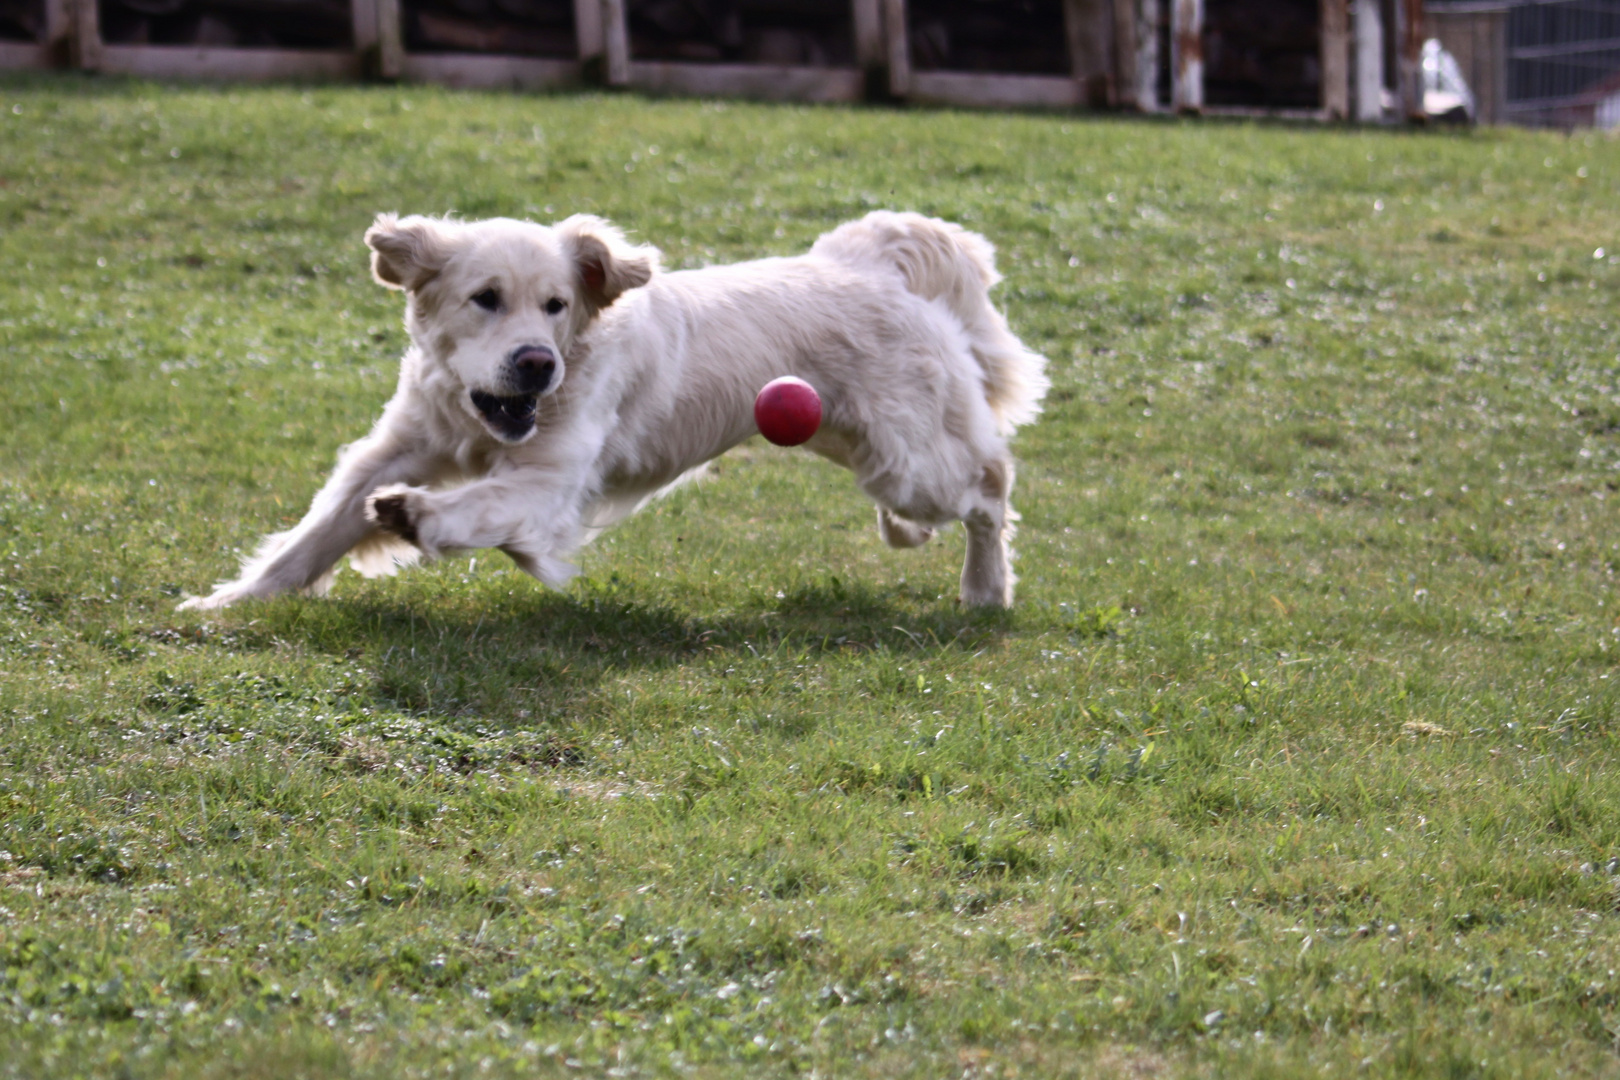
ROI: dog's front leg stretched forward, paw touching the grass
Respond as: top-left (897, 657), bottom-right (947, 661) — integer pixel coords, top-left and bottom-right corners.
top-left (180, 431), bottom-right (437, 610)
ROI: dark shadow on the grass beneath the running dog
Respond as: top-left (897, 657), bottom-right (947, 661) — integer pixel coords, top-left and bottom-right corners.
top-left (266, 578), bottom-right (1009, 724)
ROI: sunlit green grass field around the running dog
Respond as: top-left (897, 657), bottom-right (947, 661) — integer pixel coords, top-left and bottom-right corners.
top-left (0, 78), bottom-right (1620, 1078)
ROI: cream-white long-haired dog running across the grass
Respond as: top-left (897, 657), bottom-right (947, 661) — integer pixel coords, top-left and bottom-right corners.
top-left (181, 212), bottom-right (1048, 609)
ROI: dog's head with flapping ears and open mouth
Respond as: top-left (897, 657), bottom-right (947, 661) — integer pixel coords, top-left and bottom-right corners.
top-left (366, 214), bottom-right (658, 444)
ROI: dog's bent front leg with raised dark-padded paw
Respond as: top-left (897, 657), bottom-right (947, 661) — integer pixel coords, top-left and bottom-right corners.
top-left (366, 468), bottom-right (586, 586)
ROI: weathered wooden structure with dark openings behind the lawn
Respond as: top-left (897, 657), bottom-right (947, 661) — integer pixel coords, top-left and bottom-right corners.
top-left (0, 0), bottom-right (1445, 120)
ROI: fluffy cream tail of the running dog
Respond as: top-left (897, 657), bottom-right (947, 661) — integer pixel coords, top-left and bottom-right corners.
top-left (810, 210), bottom-right (1051, 436)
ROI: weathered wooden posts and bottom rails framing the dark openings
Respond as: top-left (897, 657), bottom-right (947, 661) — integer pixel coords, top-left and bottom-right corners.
top-left (0, 0), bottom-right (1341, 118)
